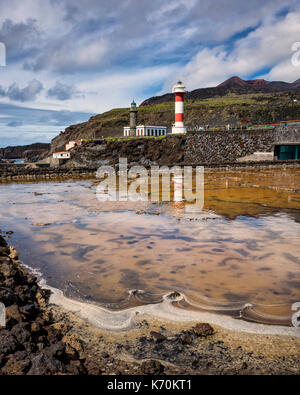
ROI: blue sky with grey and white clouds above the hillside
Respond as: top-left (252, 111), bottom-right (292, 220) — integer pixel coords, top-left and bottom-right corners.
top-left (0, 0), bottom-right (300, 147)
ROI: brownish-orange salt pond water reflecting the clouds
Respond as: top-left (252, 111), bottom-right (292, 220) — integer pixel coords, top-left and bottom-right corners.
top-left (0, 169), bottom-right (300, 325)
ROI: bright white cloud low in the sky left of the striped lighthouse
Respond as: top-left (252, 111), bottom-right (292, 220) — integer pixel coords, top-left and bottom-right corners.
top-left (1, 65), bottom-right (176, 113)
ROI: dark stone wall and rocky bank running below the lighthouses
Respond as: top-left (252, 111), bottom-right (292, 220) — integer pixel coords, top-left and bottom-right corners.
top-left (64, 127), bottom-right (300, 168)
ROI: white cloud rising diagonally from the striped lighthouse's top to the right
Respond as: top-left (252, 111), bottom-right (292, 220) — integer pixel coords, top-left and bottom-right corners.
top-left (165, 10), bottom-right (300, 90)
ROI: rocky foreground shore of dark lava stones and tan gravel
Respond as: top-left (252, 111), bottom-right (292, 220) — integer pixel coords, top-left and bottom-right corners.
top-left (0, 232), bottom-right (300, 375)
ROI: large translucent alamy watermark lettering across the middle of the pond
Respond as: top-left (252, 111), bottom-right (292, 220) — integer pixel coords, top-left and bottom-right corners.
top-left (96, 158), bottom-right (204, 213)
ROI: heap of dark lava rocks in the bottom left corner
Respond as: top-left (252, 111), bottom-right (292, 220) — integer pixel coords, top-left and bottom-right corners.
top-left (0, 236), bottom-right (86, 375)
